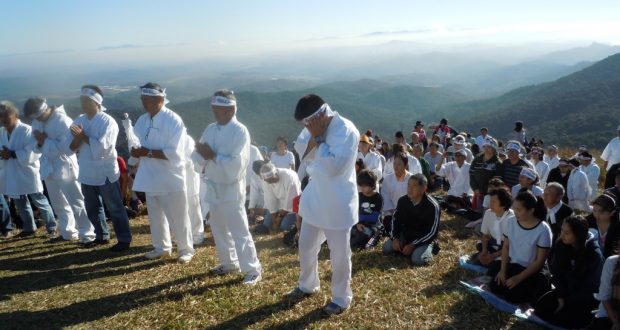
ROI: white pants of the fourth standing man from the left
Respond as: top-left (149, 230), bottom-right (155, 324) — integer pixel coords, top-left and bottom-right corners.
top-left (146, 192), bottom-right (194, 255)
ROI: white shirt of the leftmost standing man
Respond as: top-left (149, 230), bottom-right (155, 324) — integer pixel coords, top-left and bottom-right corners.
top-left (0, 119), bottom-right (43, 198)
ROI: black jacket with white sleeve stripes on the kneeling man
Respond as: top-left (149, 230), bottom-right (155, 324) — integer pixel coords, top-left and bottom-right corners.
top-left (392, 194), bottom-right (441, 246)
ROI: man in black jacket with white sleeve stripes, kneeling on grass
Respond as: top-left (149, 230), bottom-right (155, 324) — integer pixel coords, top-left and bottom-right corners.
top-left (383, 174), bottom-right (441, 266)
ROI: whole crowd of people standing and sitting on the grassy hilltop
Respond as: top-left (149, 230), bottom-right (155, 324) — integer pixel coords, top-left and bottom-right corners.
top-left (0, 83), bottom-right (620, 329)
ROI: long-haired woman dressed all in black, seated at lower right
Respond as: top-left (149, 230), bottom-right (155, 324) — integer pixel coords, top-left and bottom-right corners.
top-left (534, 216), bottom-right (604, 328)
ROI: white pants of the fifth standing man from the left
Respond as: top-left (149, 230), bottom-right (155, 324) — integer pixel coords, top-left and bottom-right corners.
top-left (209, 200), bottom-right (262, 275)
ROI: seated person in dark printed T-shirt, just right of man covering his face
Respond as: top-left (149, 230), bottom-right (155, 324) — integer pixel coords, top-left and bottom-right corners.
top-left (351, 170), bottom-right (383, 249)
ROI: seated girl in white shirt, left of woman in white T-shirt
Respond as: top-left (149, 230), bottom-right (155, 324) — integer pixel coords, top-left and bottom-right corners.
top-left (476, 189), bottom-right (516, 276)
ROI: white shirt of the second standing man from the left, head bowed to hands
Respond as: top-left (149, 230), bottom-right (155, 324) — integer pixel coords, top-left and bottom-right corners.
top-left (32, 105), bottom-right (79, 181)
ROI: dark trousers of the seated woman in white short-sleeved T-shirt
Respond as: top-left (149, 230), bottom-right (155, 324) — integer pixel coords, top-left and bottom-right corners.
top-left (490, 263), bottom-right (550, 304)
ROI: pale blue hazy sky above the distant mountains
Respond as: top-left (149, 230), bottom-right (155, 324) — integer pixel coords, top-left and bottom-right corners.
top-left (0, 0), bottom-right (620, 68)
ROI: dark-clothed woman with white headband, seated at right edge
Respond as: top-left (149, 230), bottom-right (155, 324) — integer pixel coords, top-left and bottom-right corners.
top-left (588, 194), bottom-right (620, 258)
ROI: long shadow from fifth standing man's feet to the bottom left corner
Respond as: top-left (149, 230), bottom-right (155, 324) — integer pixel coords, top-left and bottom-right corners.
top-left (0, 274), bottom-right (238, 329)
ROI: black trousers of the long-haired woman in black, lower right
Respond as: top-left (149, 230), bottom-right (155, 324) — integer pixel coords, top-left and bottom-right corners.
top-left (533, 290), bottom-right (597, 329)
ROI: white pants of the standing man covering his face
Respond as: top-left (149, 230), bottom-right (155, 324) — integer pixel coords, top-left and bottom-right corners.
top-left (299, 220), bottom-right (353, 308)
